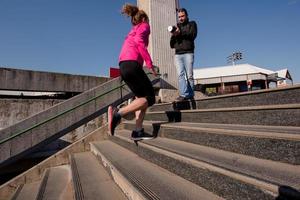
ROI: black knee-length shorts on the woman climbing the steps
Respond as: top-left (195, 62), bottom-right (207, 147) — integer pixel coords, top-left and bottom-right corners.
top-left (119, 61), bottom-right (155, 106)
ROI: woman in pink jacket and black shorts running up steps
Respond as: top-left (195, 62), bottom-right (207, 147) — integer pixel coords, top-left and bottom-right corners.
top-left (108, 4), bottom-right (157, 140)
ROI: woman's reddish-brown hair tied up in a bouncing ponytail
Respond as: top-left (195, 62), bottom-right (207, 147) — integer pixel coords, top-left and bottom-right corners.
top-left (122, 3), bottom-right (149, 25)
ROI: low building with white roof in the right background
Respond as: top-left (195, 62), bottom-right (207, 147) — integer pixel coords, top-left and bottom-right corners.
top-left (194, 64), bottom-right (293, 95)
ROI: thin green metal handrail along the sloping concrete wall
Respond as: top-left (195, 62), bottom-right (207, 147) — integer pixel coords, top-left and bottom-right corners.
top-left (0, 73), bottom-right (159, 145)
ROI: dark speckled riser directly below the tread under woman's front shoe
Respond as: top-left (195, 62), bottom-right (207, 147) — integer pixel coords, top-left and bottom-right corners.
top-left (109, 133), bottom-right (274, 200)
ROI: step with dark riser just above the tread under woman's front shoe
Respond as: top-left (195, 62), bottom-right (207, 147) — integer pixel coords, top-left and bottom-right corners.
top-left (124, 121), bottom-right (300, 165)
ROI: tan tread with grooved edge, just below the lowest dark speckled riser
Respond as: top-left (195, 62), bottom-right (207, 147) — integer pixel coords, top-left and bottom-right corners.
top-left (91, 140), bottom-right (222, 200)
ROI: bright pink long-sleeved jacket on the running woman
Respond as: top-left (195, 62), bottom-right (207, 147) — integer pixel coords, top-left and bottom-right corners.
top-left (119, 22), bottom-right (153, 69)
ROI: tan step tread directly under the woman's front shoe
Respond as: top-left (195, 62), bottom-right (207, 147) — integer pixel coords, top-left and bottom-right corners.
top-left (118, 130), bottom-right (300, 188)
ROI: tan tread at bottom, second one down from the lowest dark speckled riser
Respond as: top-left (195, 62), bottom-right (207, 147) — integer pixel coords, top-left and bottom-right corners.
top-left (70, 152), bottom-right (127, 200)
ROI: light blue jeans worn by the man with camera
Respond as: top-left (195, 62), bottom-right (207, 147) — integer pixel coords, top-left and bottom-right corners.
top-left (174, 53), bottom-right (194, 98)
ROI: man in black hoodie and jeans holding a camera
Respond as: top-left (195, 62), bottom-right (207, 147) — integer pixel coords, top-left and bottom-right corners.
top-left (170, 8), bottom-right (197, 101)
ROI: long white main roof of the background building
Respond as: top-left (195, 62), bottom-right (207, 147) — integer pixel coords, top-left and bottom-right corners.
top-left (194, 64), bottom-right (276, 79)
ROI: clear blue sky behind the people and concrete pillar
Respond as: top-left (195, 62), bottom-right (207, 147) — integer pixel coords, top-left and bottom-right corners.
top-left (0, 0), bottom-right (300, 83)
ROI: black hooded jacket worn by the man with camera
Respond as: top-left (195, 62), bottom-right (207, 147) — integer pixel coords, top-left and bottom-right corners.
top-left (170, 20), bottom-right (197, 54)
